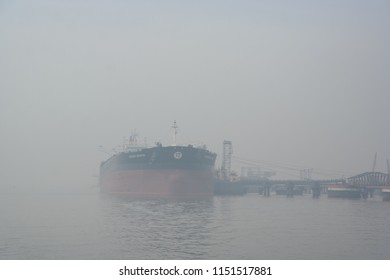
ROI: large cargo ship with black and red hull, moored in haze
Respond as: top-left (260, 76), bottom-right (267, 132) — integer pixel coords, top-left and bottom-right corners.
top-left (99, 122), bottom-right (217, 198)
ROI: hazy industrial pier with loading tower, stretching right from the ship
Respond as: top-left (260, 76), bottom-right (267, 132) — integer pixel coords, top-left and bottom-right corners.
top-left (214, 140), bottom-right (390, 201)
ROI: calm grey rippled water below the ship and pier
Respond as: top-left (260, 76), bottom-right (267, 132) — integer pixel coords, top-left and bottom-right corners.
top-left (0, 192), bottom-right (390, 260)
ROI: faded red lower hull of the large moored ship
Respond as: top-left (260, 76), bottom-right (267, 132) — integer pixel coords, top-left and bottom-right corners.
top-left (100, 169), bottom-right (214, 198)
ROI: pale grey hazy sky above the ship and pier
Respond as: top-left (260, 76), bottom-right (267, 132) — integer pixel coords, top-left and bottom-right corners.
top-left (0, 0), bottom-right (390, 188)
